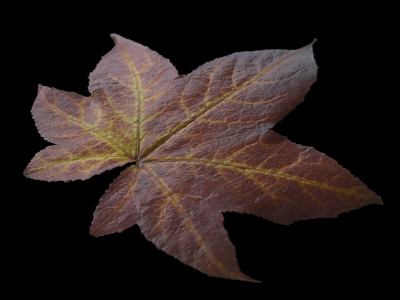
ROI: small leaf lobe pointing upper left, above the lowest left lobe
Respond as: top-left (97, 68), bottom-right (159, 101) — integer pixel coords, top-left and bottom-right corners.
top-left (32, 85), bottom-right (136, 157)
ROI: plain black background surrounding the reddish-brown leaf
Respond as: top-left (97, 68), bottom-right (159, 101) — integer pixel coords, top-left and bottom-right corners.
top-left (7, 1), bottom-right (398, 299)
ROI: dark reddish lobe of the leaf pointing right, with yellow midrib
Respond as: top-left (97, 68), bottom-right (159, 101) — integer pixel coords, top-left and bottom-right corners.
top-left (144, 130), bottom-right (382, 224)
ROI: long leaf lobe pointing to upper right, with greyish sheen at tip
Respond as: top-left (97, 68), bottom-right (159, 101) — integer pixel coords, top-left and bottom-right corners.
top-left (143, 43), bottom-right (317, 158)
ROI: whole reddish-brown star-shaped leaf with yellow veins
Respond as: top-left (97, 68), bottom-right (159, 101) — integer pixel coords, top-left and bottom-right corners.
top-left (24, 35), bottom-right (382, 281)
